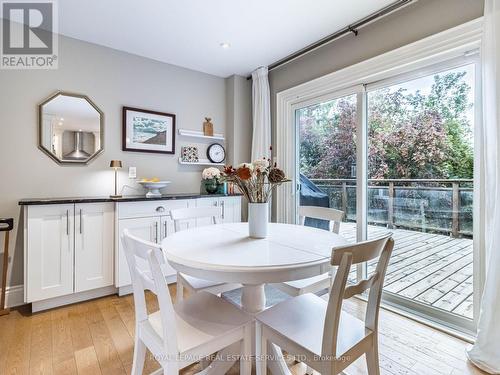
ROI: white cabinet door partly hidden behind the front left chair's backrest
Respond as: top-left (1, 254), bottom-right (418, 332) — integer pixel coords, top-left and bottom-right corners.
top-left (116, 217), bottom-right (161, 287)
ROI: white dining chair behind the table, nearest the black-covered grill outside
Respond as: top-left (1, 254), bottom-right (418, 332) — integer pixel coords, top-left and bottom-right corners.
top-left (273, 206), bottom-right (344, 296)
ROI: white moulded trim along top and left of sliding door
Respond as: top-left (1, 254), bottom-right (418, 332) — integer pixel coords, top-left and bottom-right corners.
top-left (276, 17), bottom-right (483, 223)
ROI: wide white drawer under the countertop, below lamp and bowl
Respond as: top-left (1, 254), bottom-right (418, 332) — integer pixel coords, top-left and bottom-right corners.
top-left (117, 199), bottom-right (191, 219)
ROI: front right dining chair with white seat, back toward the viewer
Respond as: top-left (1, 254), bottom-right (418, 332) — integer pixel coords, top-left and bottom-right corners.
top-left (256, 235), bottom-right (394, 375)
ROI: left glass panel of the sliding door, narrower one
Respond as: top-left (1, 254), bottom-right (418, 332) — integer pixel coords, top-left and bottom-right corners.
top-left (295, 94), bottom-right (358, 282)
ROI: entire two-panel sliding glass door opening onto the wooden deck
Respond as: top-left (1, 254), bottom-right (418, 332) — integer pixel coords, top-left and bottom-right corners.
top-left (295, 58), bottom-right (478, 330)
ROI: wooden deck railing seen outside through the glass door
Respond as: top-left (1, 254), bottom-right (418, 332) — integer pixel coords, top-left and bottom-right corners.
top-left (311, 179), bottom-right (473, 237)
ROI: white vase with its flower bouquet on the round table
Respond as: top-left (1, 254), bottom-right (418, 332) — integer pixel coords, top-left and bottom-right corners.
top-left (223, 158), bottom-right (290, 238)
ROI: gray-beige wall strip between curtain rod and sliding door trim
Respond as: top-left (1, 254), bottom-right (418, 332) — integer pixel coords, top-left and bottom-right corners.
top-left (269, 0), bottom-right (484, 139)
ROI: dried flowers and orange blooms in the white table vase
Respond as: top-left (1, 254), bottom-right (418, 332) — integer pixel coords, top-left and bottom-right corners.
top-left (222, 158), bottom-right (290, 203)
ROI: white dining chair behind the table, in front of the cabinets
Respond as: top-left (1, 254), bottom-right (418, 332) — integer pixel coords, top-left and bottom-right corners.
top-left (170, 207), bottom-right (242, 302)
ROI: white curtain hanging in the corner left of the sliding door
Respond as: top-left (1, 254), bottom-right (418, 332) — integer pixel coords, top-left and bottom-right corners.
top-left (252, 67), bottom-right (271, 160)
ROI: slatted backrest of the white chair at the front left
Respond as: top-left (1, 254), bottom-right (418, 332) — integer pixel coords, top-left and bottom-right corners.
top-left (122, 230), bottom-right (178, 358)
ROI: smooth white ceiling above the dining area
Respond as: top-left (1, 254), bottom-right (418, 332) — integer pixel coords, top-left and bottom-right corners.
top-left (58, 0), bottom-right (393, 77)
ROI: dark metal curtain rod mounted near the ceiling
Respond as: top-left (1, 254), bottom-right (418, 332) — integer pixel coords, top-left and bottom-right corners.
top-left (247, 0), bottom-right (418, 80)
